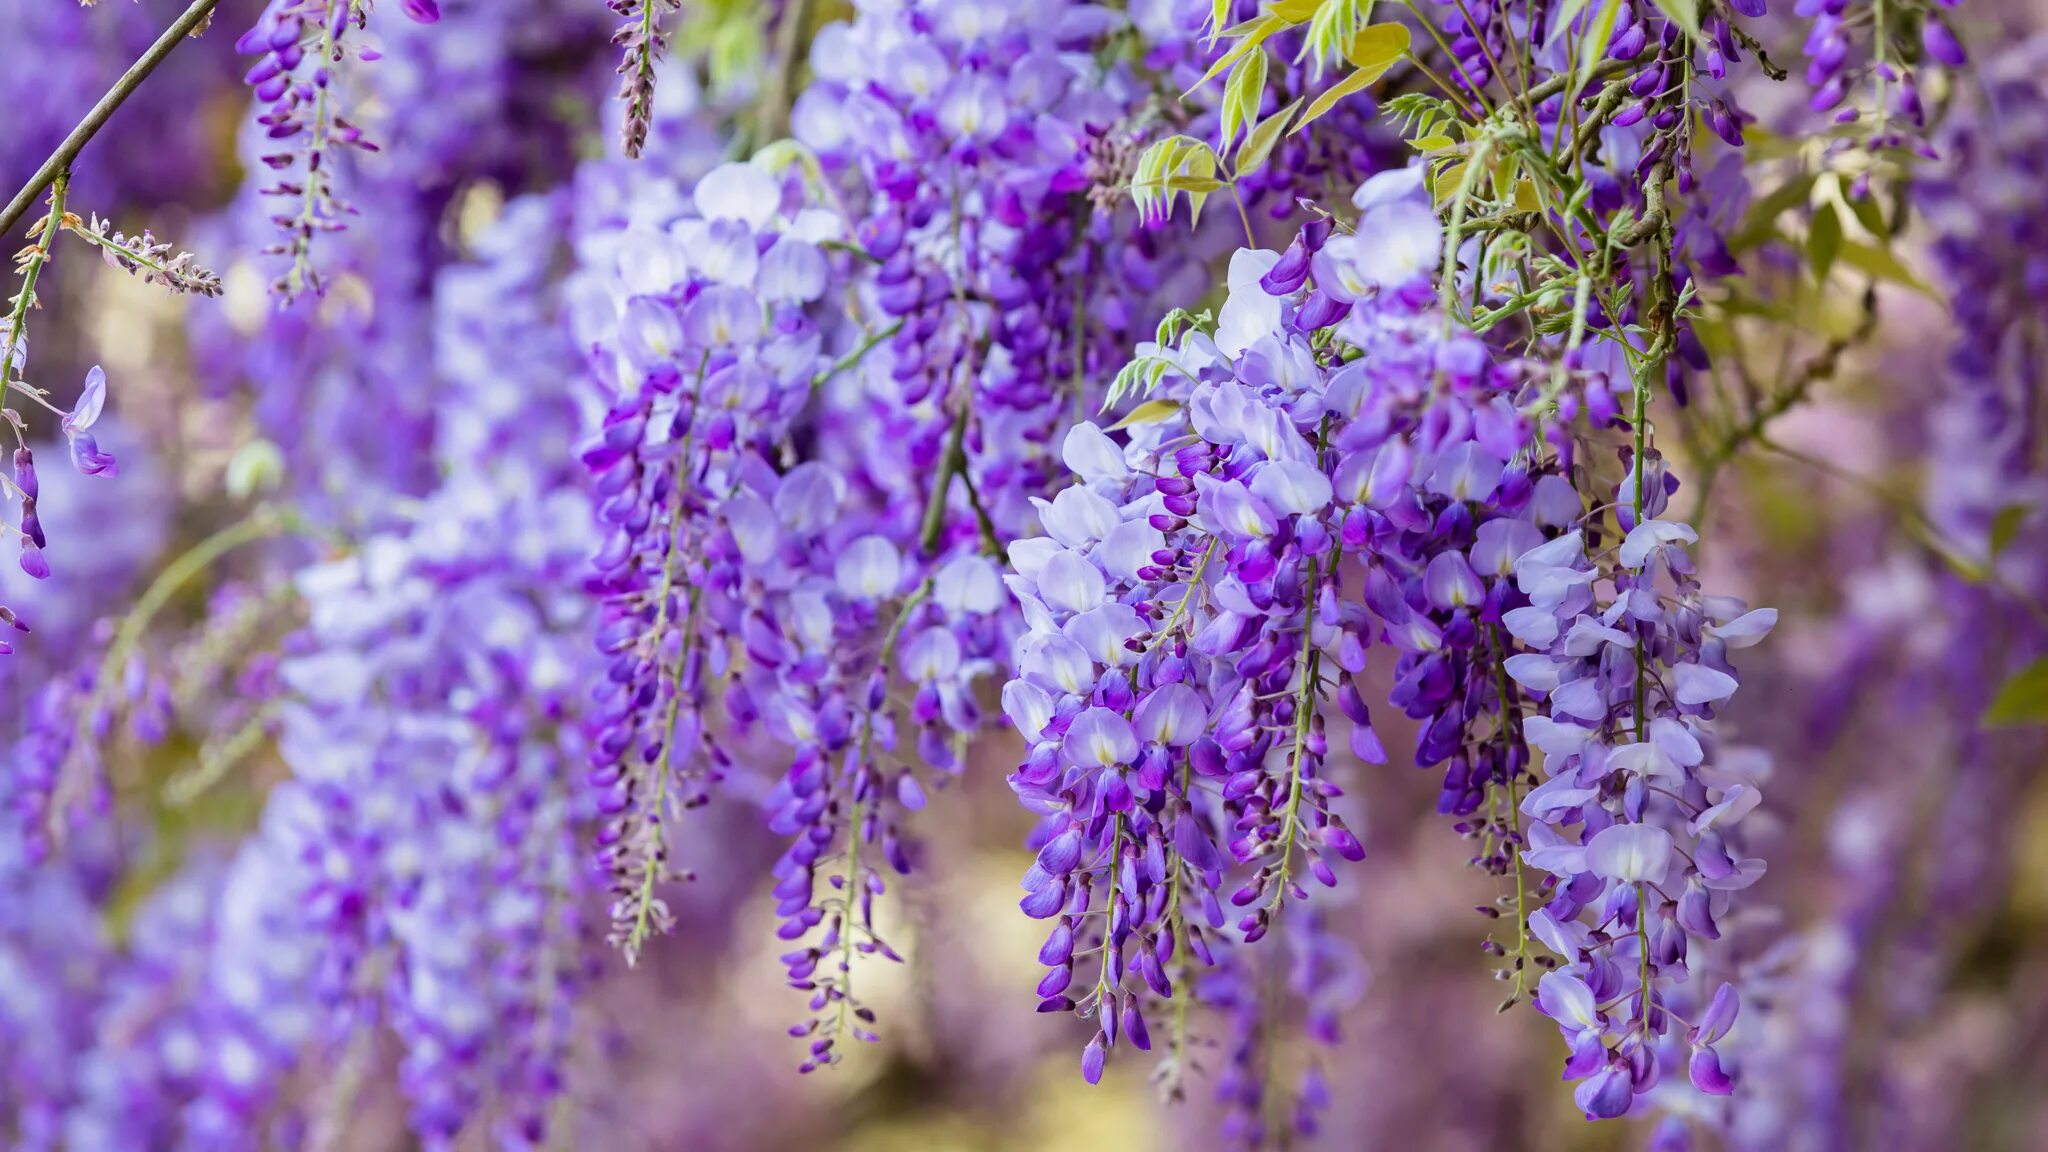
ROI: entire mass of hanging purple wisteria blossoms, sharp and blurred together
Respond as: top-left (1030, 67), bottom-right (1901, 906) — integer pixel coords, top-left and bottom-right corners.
top-left (0, 0), bottom-right (2048, 1152)
